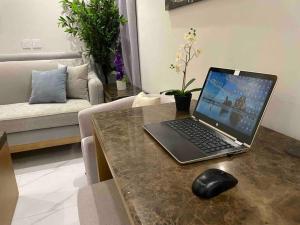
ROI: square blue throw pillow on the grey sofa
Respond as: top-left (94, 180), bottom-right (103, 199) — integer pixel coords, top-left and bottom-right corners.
top-left (29, 67), bottom-right (67, 104)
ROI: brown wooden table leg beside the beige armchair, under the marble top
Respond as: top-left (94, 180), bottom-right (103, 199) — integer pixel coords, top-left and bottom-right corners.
top-left (94, 133), bottom-right (113, 181)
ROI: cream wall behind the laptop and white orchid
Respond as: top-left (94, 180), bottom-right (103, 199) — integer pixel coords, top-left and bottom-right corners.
top-left (137, 0), bottom-right (300, 139)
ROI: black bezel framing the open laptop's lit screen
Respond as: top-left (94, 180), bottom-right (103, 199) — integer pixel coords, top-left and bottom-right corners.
top-left (193, 67), bottom-right (277, 145)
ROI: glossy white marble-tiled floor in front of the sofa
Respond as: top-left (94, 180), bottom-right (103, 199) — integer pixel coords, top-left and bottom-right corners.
top-left (12, 144), bottom-right (86, 225)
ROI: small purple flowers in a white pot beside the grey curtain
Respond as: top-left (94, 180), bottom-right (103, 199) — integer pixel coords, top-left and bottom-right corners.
top-left (114, 51), bottom-right (127, 91)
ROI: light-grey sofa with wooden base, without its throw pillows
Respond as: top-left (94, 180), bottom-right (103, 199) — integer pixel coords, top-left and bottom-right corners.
top-left (0, 52), bottom-right (103, 153)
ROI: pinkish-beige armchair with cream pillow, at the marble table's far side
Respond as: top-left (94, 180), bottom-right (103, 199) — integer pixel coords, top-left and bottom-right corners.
top-left (78, 95), bottom-right (175, 184)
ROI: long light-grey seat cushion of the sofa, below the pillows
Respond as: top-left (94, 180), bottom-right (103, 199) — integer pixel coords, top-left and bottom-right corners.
top-left (0, 99), bottom-right (91, 133)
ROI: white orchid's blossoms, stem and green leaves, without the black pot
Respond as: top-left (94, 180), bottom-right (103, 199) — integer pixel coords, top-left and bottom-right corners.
top-left (161, 28), bottom-right (201, 96)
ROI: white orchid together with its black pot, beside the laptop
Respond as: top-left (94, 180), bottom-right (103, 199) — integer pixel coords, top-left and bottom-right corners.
top-left (161, 28), bottom-right (201, 111)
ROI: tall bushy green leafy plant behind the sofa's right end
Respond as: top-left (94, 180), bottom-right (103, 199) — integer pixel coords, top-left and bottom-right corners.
top-left (58, 0), bottom-right (127, 83)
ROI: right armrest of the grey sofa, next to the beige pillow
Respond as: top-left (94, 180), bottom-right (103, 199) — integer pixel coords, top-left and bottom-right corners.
top-left (88, 71), bottom-right (104, 105)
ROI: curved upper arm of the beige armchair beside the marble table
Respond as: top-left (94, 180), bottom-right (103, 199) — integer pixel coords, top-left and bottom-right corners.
top-left (78, 96), bottom-right (135, 138)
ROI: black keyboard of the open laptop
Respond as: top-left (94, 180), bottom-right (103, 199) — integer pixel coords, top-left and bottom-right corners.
top-left (166, 119), bottom-right (234, 153)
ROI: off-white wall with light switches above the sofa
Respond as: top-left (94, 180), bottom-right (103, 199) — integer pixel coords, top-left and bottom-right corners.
top-left (0, 0), bottom-right (74, 54)
